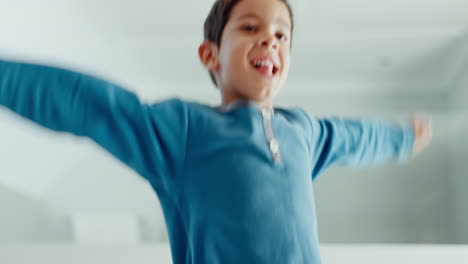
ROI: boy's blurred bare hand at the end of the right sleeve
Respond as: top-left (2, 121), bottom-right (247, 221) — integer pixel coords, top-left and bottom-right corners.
top-left (412, 113), bottom-right (432, 157)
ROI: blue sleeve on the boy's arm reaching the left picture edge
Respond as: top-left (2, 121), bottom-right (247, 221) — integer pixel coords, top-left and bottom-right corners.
top-left (0, 60), bottom-right (188, 196)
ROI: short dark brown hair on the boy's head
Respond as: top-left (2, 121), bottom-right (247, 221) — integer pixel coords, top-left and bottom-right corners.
top-left (203, 0), bottom-right (294, 85)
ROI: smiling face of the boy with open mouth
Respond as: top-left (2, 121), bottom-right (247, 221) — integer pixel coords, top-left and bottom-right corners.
top-left (210, 0), bottom-right (291, 106)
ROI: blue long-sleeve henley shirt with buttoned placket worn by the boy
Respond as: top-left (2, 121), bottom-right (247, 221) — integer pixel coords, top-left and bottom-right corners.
top-left (0, 58), bottom-right (414, 264)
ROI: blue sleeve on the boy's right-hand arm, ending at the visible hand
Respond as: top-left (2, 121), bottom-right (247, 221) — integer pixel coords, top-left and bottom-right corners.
top-left (309, 114), bottom-right (414, 179)
